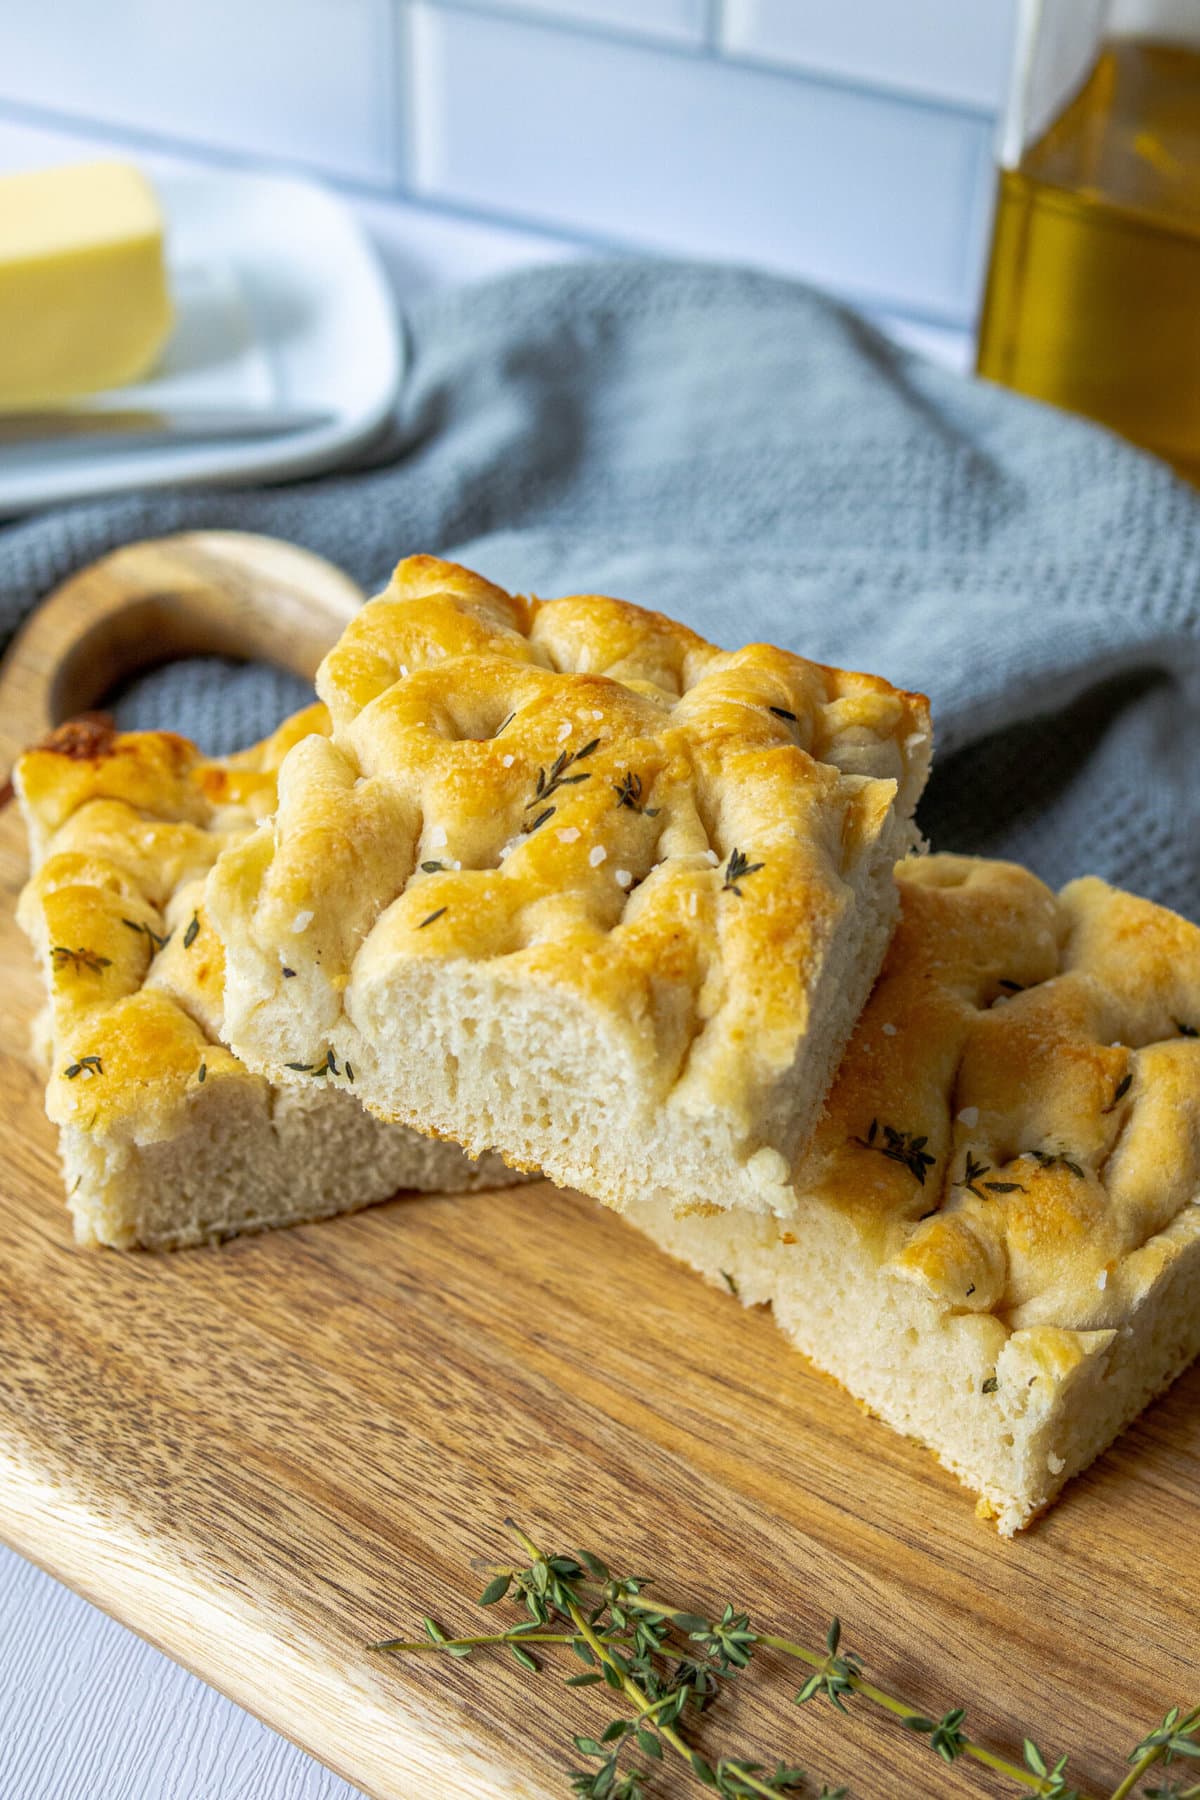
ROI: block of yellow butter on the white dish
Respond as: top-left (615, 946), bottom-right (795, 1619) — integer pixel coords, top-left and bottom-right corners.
top-left (0, 162), bottom-right (171, 410)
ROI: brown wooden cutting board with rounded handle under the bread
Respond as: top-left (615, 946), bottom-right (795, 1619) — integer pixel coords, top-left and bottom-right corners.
top-left (0, 535), bottom-right (1200, 1800)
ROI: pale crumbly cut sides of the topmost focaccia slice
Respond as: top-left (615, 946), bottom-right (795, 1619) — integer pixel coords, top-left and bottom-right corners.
top-left (209, 810), bottom-right (918, 1217)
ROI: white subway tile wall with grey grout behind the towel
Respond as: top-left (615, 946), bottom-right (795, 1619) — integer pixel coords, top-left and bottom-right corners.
top-left (0, 0), bottom-right (1016, 333)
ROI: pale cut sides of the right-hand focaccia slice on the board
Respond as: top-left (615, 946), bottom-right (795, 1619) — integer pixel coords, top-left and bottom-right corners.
top-left (626, 1195), bottom-right (1200, 1537)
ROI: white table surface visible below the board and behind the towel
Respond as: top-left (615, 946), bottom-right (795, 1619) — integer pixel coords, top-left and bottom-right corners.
top-left (0, 121), bottom-right (966, 1800)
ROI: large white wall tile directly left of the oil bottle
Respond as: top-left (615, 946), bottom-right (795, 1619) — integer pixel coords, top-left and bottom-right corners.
top-left (410, 0), bottom-right (991, 319)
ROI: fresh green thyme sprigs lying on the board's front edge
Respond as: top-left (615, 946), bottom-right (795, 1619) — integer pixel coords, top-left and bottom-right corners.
top-left (371, 1519), bottom-right (1200, 1800)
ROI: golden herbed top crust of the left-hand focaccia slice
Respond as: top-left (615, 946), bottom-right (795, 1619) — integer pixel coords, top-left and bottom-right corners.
top-left (14, 706), bottom-right (327, 1132)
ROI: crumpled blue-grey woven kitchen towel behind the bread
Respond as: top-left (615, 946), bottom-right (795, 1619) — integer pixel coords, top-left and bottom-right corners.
top-left (0, 261), bottom-right (1200, 916)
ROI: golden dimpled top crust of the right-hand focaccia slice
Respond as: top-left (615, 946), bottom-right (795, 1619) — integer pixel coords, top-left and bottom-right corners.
top-left (797, 855), bottom-right (1200, 1330)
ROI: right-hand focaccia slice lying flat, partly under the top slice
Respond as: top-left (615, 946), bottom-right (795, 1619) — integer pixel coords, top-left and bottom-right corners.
top-left (628, 855), bottom-right (1200, 1535)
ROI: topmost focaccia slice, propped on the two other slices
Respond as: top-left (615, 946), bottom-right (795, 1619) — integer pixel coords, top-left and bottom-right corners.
top-left (207, 556), bottom-right (930, 1215)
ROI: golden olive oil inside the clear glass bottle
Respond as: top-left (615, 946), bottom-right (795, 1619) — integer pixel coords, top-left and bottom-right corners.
top-left (979, 40), bottom-right (1200, 482)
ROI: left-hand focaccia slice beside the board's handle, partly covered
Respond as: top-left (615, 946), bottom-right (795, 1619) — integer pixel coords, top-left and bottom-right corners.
top-left (14, 706), bottom-right (513, 1249)
